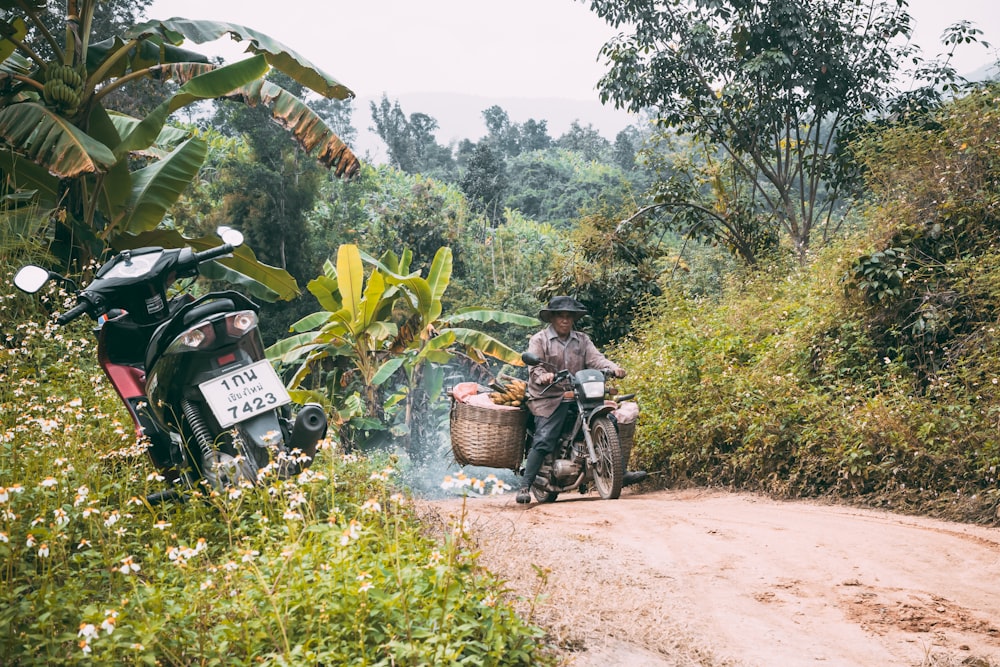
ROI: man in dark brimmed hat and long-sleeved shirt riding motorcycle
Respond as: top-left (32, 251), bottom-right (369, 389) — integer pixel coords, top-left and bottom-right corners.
top-left (516, 296), bottom-right (646, 504)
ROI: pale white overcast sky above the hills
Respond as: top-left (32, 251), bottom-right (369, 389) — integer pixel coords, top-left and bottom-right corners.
top-left (148, 0), bottom-right (1000, 100)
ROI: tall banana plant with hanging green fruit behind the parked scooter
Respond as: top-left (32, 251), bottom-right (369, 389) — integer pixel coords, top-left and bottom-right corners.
top-left (0, 0), bottom-right (360, 299)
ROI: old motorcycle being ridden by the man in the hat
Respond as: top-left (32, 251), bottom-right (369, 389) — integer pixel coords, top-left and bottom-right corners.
top-left (521, 352), bottom-right (635, 503)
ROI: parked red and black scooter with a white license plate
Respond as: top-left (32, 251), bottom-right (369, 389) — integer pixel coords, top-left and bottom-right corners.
top-left (14, 227), bottom-right (327, 504)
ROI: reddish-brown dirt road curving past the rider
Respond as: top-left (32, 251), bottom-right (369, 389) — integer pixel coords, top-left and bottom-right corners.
top-left (430, 489), bottom-right (1000, 667)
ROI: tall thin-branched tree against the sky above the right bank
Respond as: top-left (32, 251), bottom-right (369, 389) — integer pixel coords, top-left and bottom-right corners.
top-left (591, 0), bottom-right (980, 260)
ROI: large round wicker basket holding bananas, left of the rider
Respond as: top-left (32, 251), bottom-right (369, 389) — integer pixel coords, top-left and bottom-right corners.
top-left (451, 401), bottom-right (528, 471)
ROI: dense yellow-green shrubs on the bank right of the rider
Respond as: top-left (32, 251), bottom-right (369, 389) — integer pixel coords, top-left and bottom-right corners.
top-left (613, 242), bottom-right (1000, 520)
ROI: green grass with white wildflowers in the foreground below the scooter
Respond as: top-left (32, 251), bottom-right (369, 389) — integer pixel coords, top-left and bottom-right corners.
top-left (0, 268), bottom-right (552, 666)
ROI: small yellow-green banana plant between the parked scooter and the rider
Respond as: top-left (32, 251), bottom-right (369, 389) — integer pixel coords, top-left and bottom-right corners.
top-left (268, 245), bottom-right (539, 452)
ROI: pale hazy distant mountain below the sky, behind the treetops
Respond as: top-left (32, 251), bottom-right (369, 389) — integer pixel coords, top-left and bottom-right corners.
top-left (353, 93), bottom-right (639, 162)
